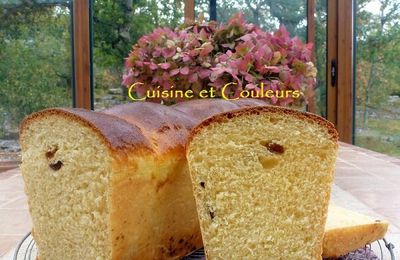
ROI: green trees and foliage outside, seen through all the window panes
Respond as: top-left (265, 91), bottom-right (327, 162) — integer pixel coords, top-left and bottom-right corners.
top-left (0, 0), bottom-right (400, 156)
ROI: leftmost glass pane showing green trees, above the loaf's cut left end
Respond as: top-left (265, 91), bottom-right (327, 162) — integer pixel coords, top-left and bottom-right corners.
top-left (0, 1), bottom-right (72, 169)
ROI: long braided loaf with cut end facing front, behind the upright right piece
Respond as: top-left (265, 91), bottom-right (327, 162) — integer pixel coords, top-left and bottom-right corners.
top-left (20, 100), bottom-right (263, 260)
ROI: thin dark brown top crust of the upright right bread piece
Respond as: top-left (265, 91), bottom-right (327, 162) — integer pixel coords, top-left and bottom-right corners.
top-left (187, 106), bottom-right (339, 144)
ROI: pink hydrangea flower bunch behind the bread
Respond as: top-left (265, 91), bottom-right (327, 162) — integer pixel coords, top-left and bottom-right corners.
top-left (122, 13), bottom-right (316, 106)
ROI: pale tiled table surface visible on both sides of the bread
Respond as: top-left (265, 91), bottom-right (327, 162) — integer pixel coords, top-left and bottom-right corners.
top-left (0, 143), bottom-right (400, 259)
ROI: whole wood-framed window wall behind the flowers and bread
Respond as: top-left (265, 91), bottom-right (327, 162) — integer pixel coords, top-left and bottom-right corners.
top-left (0, 0), bottom-right (400, 158)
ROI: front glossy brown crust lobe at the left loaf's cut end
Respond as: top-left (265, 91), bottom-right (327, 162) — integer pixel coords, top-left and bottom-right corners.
top-left (20, 108), bottom-right (152, 151)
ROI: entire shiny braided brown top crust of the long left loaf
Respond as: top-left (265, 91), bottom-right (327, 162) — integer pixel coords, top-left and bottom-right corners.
top-left (20, 99), bottom-right (282, 154)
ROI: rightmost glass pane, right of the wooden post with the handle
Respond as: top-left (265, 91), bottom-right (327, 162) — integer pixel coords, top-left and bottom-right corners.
top-left (355, 0), bottom-right (400, 157)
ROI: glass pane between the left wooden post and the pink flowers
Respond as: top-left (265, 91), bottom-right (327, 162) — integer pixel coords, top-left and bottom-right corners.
top-left (93, 0), bottom-right (184, 109)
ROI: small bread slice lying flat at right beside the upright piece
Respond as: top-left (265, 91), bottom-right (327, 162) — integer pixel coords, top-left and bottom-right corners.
top-left (322, 205), bottom-right (389, 258)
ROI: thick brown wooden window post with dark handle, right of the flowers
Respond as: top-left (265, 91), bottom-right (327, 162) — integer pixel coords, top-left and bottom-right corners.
top-left (326, 0), bottom-right (355, 144)
